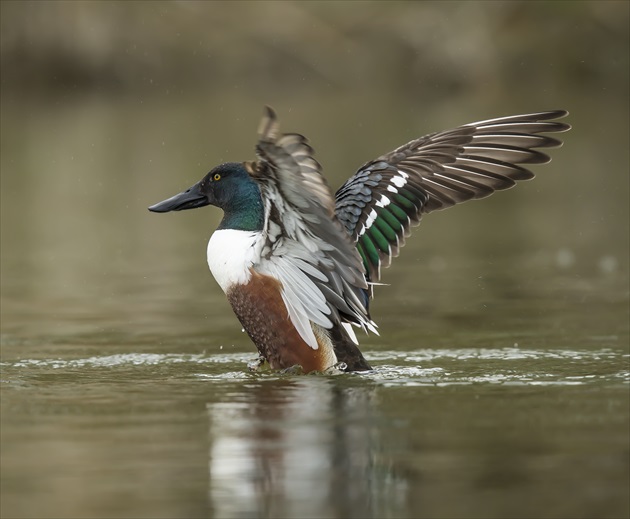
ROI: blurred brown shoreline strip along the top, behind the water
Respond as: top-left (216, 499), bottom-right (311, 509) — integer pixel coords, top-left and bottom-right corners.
top-left (0, 1), bottom-right (629, 102)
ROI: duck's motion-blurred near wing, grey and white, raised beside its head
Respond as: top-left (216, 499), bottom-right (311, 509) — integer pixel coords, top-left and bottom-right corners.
top-left (247, 107), bottom-right (374, 349)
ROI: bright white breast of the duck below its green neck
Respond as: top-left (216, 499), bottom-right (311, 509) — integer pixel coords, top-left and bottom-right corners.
top-left (208, 229), bottom-right (262, 292)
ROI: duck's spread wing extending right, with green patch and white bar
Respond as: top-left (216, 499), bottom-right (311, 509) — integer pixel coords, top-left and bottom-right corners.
top-left (335, 110), bottom-right (571, 281)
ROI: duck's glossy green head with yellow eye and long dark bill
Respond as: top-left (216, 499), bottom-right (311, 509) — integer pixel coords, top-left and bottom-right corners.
top-left (149, 162), bottom-right (265, 231)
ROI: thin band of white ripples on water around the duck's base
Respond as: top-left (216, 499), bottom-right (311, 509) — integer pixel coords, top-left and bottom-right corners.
top-left (0, 347), bottom-right (630, 386)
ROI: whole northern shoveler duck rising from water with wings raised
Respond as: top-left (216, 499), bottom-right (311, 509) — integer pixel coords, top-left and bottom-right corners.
top-left (149, 107), bottom-right (570, 372)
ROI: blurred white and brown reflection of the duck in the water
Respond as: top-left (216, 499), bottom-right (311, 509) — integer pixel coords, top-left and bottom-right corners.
top-left (208, 376), bottom-right (407, 518)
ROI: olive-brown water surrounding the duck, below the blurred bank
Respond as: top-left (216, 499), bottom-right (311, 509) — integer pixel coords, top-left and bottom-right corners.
top-left (1, 86), bottom-right (630, 518)
